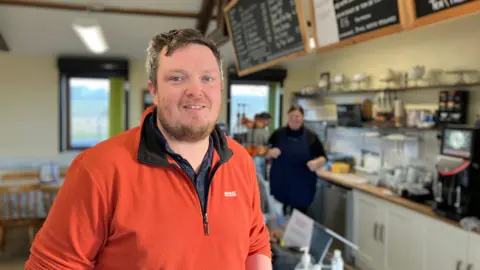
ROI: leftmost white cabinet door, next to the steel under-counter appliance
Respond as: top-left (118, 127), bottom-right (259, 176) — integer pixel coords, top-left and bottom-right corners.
top-left (354, 192), bottom-right (385, 269)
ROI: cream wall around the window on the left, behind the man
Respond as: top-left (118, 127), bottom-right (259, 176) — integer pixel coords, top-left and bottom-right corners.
top-left (0, 52), bottom-right (230, 159)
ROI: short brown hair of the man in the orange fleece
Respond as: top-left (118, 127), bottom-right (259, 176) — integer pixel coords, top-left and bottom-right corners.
top-left (145, 28), bottom-right (223, 87)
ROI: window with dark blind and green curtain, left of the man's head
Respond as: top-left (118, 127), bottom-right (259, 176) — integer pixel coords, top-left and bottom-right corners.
top-left (57, 56), bottom-right (129, 152)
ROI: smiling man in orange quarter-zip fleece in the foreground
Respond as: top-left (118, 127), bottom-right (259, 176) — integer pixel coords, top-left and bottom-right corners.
top-left (26, 29), bottom-right (272, 270)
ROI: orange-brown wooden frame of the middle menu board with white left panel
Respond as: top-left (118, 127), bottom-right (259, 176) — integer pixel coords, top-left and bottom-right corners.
top-left (308, 0), bottom-right (414, 53)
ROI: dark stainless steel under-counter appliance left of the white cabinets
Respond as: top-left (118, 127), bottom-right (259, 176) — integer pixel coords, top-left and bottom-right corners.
top-left (310, 178), bottom-right (353, 263)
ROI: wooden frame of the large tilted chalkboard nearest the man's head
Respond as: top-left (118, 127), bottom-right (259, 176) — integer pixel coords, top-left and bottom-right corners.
top-left (223, 0), bottom-right (311, 76)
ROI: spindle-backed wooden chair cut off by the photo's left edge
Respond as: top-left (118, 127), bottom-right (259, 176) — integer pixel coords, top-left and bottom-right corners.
top-left (0, 183), bottom-right (42, 251)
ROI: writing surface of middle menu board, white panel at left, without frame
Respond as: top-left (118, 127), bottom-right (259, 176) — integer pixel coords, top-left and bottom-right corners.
top-left (310, 0), bottom-right (405, 47)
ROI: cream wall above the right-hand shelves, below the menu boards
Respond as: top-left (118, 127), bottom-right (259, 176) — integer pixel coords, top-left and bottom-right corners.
top-left (313, 14), bottom-right (480, 123)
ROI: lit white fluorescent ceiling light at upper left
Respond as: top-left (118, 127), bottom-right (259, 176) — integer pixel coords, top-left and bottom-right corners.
top-left (72, 19), bottom-right (108, 54)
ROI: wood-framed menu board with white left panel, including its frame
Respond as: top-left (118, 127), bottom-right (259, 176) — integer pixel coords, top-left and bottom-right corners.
top-left (309, 0), bottom-right (409, 51)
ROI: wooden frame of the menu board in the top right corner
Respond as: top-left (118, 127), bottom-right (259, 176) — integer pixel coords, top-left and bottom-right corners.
top-left (405, 0), bottom-right (480, 28)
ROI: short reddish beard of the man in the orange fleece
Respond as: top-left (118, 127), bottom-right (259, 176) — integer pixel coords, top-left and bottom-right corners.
top-left (156, 105), bottom-right (215, 143)
